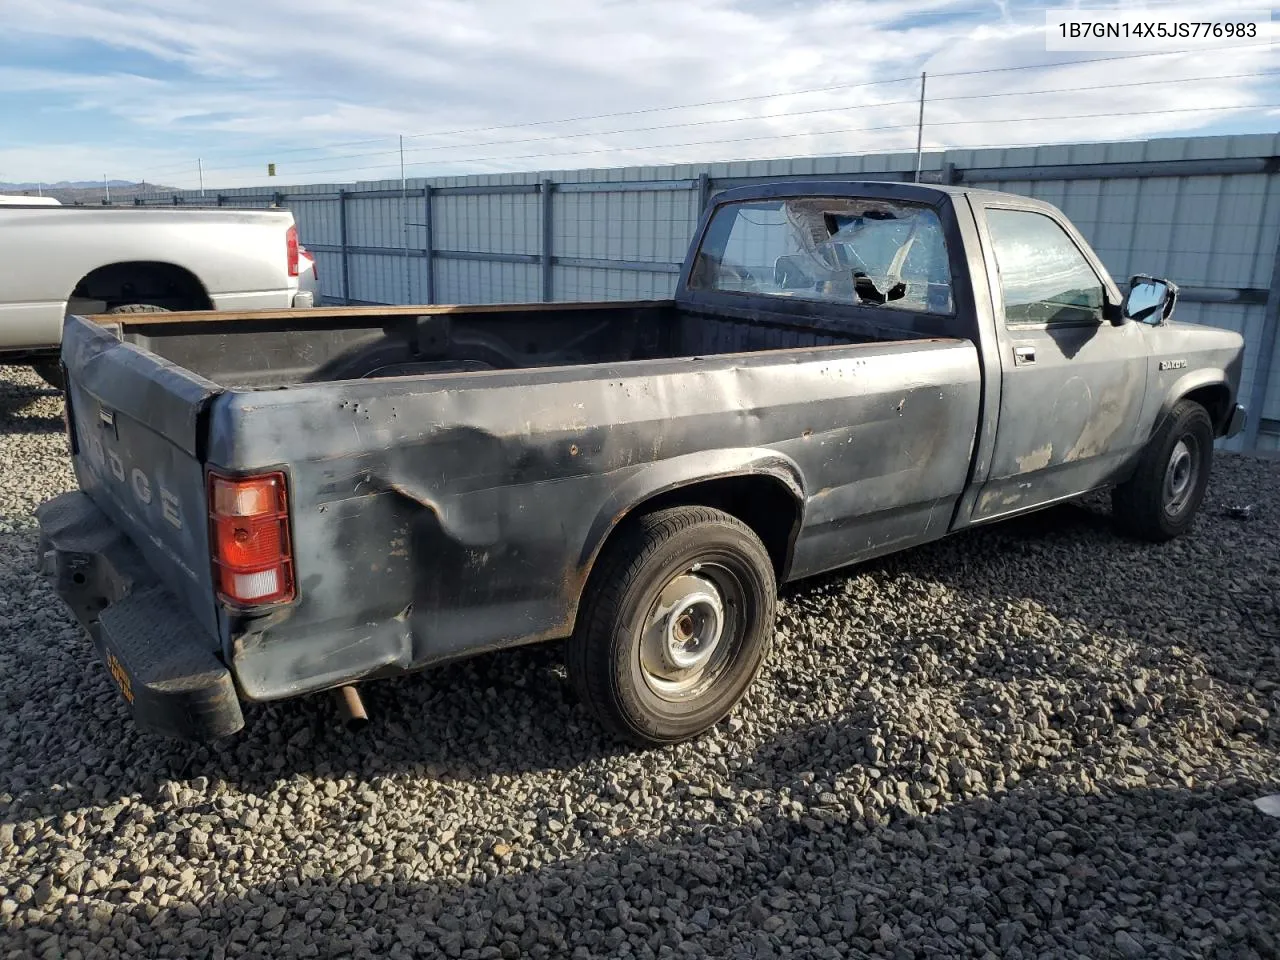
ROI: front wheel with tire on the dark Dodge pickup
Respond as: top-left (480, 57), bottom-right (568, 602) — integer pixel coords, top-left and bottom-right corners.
top-left (1111, 399), bottom-right (1213, 543)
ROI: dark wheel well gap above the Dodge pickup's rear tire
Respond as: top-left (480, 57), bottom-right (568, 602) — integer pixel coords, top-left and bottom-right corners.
top-left (611, 474), bottom-right (800, 585)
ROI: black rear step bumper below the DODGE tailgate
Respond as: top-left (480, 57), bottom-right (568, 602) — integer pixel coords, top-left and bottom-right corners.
top-left (36, 490), bottom-right (244, 740)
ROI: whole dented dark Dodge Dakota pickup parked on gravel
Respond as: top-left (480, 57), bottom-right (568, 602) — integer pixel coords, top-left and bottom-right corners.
top-left (38, 180), bottom-right (1244, 744)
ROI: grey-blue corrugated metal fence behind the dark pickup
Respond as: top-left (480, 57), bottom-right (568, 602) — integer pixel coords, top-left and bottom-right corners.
top-left (137, 134), bottom-right (1280, 449)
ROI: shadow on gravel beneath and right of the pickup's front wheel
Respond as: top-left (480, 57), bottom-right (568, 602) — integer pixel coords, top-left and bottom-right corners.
top-left (860, 486), bottom-right (1280, 687)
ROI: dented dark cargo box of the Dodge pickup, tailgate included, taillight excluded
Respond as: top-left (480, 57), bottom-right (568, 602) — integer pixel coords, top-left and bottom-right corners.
top-left (63, 302), bottom-right (982, 700)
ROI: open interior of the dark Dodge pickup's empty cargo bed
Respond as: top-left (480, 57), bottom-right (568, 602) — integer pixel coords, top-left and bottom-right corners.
top-left (90, 301), bottom-right (923, 389)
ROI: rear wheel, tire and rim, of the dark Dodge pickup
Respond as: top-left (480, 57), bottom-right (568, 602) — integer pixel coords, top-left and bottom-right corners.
top-left (566, 507), bottom-right (777, 746)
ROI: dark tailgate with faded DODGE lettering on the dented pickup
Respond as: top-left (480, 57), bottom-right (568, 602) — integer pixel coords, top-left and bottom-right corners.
top-left (63, 317), bottom-right (221, 634)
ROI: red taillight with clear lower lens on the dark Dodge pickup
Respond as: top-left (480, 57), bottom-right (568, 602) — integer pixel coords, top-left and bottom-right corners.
top-left (209, 474), bottom-right (296, 605)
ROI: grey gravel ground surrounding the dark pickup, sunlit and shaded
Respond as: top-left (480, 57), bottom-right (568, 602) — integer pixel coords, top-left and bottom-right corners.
top-left (0, 369), bottom-right (1280, 959)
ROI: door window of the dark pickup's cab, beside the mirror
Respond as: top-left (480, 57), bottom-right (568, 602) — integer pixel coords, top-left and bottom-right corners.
top-left (987, 209), bottom-right (1103, 324)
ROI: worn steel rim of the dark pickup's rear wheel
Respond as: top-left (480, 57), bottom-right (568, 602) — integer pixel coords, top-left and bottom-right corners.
top-left (640, 563), bottom-right (741, 701)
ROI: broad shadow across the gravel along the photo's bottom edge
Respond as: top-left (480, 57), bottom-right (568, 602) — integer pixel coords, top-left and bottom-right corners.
top-left (9, 785), bottom-right (1280, 957)
